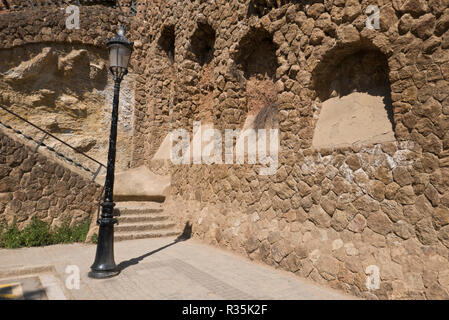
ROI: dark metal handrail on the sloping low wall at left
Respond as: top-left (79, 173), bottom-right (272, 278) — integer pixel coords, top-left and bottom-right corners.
top-left (0, 105), bottom-right (106, 181)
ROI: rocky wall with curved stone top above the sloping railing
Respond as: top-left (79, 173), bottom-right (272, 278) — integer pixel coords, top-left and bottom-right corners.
top-left (0, 2), bottom-right (135, 172)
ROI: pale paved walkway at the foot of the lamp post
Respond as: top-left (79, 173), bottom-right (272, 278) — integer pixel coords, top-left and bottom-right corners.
top-left (0, 238), bottom-right (352, 300)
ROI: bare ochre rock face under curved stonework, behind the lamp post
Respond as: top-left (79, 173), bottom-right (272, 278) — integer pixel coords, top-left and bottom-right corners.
top-left (0, 43), bottom-right (134, 168)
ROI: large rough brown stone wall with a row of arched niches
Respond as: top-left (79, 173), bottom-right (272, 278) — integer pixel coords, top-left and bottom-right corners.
top-left (133, 0), bottom-right (449, 299)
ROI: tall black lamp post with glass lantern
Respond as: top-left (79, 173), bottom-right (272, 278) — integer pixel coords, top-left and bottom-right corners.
top-left (89, 26), bottom-right (133, 279)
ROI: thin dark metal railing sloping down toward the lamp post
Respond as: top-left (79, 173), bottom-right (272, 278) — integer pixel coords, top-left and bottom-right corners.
top-left (0, 105), bottom-right (106, 180)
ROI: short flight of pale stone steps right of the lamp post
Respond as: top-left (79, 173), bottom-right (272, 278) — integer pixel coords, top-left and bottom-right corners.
top-left (114, 201), bottom-right (182, 241)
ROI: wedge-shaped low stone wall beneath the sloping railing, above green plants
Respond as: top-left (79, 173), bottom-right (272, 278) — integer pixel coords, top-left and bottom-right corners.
top-left (0, 129), bottom-right (101, 229)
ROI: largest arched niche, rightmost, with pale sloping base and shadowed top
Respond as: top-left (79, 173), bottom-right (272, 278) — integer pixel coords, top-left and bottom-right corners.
top-left (312, 48), bottom-right (395, 148)
